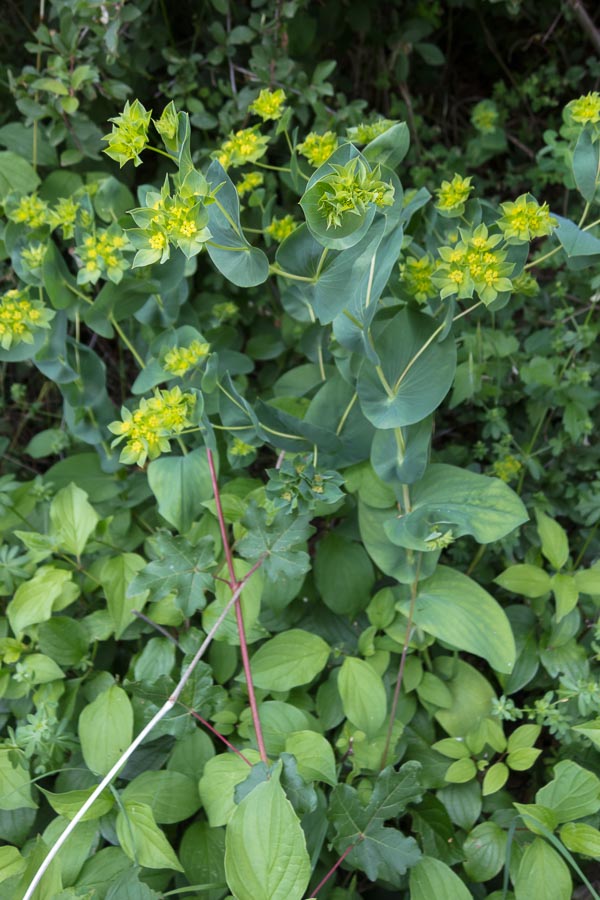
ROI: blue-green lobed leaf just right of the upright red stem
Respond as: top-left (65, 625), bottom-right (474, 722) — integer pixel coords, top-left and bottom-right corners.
top-left (236, 503), bottom-right (314, 581)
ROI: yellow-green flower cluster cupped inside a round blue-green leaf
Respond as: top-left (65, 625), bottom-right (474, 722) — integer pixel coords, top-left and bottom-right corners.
top-left (317, 157), bottom-right (394, 228)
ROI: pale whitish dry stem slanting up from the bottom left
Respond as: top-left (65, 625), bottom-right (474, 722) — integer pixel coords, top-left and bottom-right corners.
top-left (23, 557), bottom-right (264, 900)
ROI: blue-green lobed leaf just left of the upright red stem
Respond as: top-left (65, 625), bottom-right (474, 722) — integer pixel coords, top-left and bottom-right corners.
top-left (127, 534), bottom-right (215, 616)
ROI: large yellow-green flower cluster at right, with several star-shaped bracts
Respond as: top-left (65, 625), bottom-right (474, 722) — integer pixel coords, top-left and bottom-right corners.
top-left (433, 225), bottom-right (514, 306)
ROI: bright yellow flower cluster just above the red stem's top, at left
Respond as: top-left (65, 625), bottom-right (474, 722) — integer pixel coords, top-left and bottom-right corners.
top-left (108, 387), bottom-right (196, 466)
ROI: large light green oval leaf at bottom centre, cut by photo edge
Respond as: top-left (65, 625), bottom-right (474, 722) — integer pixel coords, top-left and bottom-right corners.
top-left (225, 776), bottom-right (311, 900)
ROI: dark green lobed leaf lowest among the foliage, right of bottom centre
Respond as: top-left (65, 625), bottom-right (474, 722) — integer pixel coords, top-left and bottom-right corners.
top-left (328, 761), bottom-right (422, 887)
